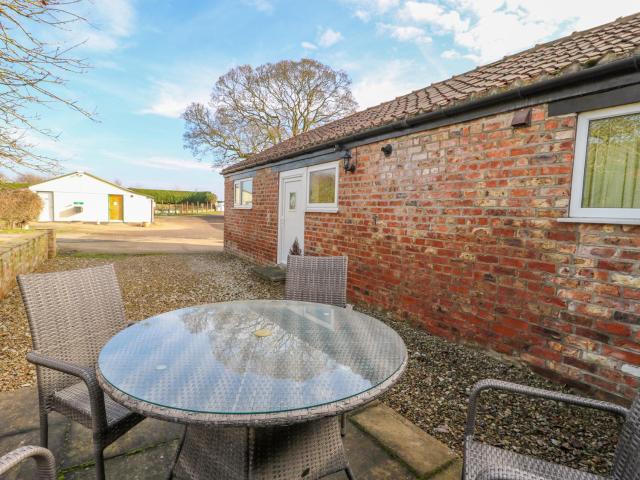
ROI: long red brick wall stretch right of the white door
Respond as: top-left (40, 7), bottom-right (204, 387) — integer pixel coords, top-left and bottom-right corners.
top-left (226, 106), bottom-right (640, 399)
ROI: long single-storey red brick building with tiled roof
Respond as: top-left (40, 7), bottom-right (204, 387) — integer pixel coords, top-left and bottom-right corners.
top-left (223, 14), bottom-right (640, 399)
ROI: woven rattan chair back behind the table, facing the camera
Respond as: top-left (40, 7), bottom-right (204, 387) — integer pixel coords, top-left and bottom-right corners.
top-left (285, 255), bottom-right (347, 307)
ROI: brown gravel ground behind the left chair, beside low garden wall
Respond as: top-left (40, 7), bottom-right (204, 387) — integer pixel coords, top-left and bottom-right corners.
top-left (0, 253), bottom-right (282, 392)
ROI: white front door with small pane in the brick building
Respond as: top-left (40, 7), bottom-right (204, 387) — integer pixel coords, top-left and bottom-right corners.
top-left (278, 171), bottom-right (305, 264)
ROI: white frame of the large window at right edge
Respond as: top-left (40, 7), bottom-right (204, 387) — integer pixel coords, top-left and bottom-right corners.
top-left (569, 103), bottom-right (640, 221)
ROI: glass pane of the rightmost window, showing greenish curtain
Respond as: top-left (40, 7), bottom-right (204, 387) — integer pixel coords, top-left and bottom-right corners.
top-left (582, 113), bottom-right (640, 208)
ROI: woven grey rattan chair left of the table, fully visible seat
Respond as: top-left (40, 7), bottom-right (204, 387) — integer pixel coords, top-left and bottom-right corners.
top-left (18, 265), bottom-right (144, 479)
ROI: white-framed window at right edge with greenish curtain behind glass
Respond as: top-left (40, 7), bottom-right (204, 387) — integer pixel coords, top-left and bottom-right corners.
top-left (570, 104), bottom-right (640, 220)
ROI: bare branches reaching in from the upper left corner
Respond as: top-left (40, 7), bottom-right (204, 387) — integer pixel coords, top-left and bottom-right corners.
top-left (0, 0), bottom-right (91, 172)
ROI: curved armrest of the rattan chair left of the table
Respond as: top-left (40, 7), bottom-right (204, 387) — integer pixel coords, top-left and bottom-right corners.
top-left (27, 351), bottom-right (107, 431)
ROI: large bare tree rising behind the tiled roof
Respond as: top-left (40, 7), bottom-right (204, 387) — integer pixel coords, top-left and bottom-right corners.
top-left (183, 59), bottom-right (358, 167)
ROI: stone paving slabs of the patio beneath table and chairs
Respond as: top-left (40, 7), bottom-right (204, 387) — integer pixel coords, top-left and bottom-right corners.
top-left (0, 387), bottom-right (461, 480)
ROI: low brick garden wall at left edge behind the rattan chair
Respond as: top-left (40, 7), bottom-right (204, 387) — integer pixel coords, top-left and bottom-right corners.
top-left (0, 230), bottom-right (56, 299)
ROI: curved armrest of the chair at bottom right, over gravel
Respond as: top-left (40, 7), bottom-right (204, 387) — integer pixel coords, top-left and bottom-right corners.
top-left (465, 379), bottom-right (629, 438)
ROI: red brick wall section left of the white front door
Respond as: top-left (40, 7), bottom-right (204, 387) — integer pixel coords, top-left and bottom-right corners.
top-left (224, 168), bottom-right (278, 264)
